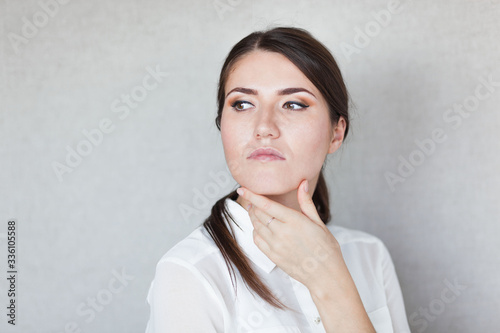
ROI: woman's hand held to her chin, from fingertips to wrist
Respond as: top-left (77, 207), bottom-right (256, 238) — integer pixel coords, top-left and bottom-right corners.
top-left (238, 180), bottom-right (346, 292)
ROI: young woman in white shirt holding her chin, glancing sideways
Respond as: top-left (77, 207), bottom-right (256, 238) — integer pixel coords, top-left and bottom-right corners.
top-left (146, 27), bottom-right (410, 333)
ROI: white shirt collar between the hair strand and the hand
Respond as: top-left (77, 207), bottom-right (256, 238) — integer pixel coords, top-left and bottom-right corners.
top-left (225, 198), bottom-right (276, 274)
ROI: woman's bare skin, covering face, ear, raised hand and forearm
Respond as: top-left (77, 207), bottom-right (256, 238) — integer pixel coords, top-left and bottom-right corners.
top-left (221, 50), bottom-right (375, 332)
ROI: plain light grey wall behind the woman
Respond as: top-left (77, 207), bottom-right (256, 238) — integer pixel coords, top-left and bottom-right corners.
top-left (0, 0), bottom-right (500, 333)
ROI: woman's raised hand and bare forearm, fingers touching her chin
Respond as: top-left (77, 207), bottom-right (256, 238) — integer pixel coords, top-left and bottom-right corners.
top-left (238, 180), bottom-right (375, 333)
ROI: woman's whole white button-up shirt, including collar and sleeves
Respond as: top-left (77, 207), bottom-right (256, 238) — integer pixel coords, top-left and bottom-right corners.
top-left (146, 198), bottom-right (410, 333)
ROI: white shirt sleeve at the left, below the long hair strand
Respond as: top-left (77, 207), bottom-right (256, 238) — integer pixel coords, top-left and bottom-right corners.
top-left (146, 260), bottom-right (224, 333)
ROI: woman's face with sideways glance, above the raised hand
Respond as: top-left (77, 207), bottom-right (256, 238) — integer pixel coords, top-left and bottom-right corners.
top-left (221, 50), bottom-right (343, 195)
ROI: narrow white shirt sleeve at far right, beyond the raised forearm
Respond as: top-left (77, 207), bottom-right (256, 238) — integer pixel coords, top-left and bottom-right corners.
top-left (381, 243), bottom-right (410, 333)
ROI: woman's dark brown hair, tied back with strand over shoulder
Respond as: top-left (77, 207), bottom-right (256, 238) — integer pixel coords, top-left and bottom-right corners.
top-left (203, 27), bottom-right (349, 309)
